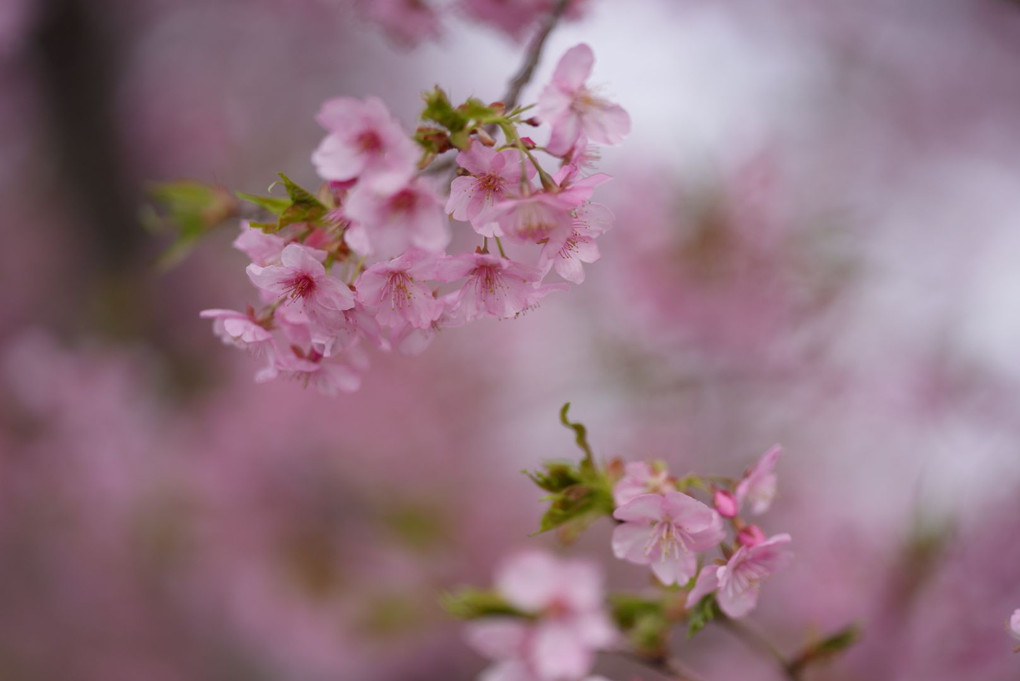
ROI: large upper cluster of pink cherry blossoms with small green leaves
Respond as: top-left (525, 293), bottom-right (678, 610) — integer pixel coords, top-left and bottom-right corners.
top-left (201, 44), bottom-right (630, 395)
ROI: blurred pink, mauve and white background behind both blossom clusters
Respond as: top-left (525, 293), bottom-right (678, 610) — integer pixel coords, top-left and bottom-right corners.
top-left (0, 0), bottom-right (1020, 681)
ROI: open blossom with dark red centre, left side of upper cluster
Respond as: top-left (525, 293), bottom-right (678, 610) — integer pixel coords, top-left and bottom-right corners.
top-left (247, 244), bottom-right (354, 331)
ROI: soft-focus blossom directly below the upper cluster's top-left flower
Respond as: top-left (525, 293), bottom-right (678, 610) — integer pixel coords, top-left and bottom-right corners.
top-left (345, 177), bottom-right (450, 258)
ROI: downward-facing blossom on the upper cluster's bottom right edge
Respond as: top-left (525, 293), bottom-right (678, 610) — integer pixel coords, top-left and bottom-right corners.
top-left (438, 253), bottom-right (566, 323)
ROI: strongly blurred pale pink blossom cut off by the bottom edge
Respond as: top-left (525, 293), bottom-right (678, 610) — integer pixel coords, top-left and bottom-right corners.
top-left (466, 552), bottom-right (618, 681)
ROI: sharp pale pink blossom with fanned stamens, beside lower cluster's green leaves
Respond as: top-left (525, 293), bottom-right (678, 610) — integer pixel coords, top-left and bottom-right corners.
top-left (612, 491), bottom-right (725, 585)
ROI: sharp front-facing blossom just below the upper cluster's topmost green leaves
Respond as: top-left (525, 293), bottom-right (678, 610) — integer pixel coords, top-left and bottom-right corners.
top-left (446, 142), bottom-right (536, 237)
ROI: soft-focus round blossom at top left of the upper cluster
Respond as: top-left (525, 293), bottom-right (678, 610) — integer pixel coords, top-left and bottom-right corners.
top-left (312, 97), bottom-right (418, 192)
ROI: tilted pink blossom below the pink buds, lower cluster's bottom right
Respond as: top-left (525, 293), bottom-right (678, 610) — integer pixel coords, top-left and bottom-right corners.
top-left (687, 534), bottom-right (791, 618)
